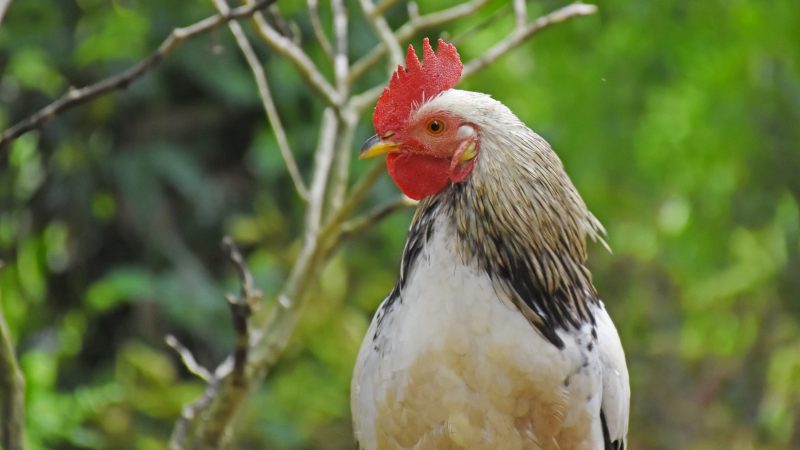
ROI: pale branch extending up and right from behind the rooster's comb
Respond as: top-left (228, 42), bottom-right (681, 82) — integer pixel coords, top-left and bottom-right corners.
top-left (462, 3), bottom-right (597, 77)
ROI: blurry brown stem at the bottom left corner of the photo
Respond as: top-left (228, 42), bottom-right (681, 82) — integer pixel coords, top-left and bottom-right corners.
top-left (0, 304), bottom-right (25, 450)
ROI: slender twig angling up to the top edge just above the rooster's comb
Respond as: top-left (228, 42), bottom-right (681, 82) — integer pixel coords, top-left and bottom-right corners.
top-left (350, 0), bottom-right (488, 83)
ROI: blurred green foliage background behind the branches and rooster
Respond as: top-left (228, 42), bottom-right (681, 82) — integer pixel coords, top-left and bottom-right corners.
top-left (0, 0), bottom-right (800, 450)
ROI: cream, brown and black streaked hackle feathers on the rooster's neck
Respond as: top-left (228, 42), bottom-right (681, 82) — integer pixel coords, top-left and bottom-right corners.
top-left (404, 92), bottom-right (603, 347)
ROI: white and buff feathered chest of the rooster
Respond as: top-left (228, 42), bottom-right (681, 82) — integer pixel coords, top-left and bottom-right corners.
top-left (352, 220), bottom-right (600, 450)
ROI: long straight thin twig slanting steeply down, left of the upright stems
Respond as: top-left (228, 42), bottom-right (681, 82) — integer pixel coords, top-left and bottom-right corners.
top-left (214, 0), bottom-right (308, 200)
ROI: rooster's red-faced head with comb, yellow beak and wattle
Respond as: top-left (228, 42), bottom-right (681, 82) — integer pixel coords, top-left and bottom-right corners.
top-left (360, 38), bottom-right (480, 200)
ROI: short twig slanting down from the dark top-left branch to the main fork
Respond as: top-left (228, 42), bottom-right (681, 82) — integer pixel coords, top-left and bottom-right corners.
top-left (248, 0), bottom-right (344, 107)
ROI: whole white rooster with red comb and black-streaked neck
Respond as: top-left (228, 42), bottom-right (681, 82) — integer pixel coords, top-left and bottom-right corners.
top-left (351, 39), bottom-right (630, 450)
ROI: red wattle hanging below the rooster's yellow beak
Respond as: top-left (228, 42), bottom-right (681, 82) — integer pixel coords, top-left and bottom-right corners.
top-left (386, 153), bottom-right (450, 200)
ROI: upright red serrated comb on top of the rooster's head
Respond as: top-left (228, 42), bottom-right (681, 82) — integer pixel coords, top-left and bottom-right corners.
top-left (372, 38), bottom-right (464, 136)
